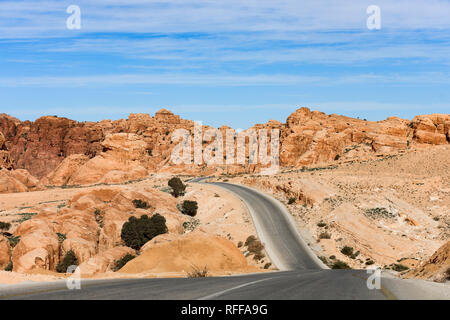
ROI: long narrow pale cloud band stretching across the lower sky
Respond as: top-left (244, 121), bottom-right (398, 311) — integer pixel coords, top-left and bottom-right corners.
top-left (0, 72), bottom-right (450, 87)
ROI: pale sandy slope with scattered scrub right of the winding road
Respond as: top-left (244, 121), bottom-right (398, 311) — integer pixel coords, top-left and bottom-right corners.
top-left (219, 146), bottom-right (450, 276)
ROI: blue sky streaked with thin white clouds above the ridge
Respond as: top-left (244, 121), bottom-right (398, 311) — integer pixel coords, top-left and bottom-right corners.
top-left (0, 0), bottom-right (450, 128)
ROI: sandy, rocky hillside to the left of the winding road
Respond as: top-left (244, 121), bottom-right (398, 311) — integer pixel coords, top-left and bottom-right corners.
top-left (0, 174), bottom-right (270, 283)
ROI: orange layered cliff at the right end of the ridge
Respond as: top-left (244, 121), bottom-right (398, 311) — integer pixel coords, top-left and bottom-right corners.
top-left (280, 108), bottom-right (450, 167)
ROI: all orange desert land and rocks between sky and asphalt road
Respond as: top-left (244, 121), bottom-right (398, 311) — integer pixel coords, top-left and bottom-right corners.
top-left (0, 108), bottom-right (450, 284)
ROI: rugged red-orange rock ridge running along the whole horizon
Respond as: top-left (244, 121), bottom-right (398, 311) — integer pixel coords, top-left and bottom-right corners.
top-left (0, 108), bottom-right (450, 180)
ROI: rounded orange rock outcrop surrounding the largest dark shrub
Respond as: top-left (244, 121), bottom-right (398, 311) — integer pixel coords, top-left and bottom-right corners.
top-left (12, 187), bottom-right (186, 273)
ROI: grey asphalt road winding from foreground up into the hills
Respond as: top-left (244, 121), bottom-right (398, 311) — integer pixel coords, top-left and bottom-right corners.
top-left (0, 183), bottom-right (450, 300)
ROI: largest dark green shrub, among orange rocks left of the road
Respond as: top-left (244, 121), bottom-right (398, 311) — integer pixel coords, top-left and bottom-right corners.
top-left (121, 214), bottom-right (168, 250)
